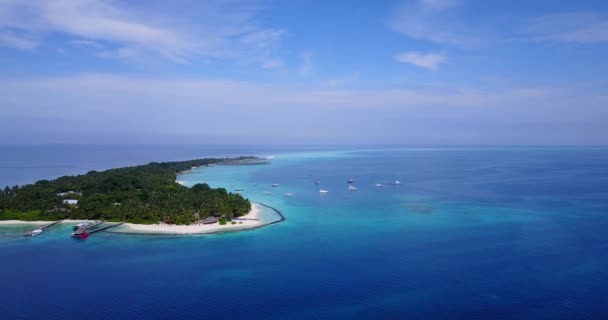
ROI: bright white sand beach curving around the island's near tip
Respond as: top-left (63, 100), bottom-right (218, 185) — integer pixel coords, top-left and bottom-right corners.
top-left (108, 202), bottom-right (268, 234)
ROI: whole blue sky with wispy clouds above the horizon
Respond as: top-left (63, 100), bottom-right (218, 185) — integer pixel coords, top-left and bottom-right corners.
top-left (0, 0), bottom-right (608, 145)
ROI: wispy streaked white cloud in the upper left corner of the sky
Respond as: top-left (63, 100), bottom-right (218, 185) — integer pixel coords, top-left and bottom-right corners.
top-left (0, 0), bottom-right (283, 62)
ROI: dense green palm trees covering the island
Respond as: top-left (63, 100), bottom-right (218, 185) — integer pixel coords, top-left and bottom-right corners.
top-left (0, 158), bottom-right (251, 224)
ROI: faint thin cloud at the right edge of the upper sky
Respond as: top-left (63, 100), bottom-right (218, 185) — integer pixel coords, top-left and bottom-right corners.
top-left (525, 12), bottom-right (608, 44)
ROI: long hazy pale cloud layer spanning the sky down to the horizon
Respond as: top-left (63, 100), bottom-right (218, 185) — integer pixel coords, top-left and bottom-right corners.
top-left (0, 75), bottom-right (608, 144)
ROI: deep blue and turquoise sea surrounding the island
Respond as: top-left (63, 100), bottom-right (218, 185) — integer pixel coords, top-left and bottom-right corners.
top-left (0, 146), bottom-right (608, 319)
